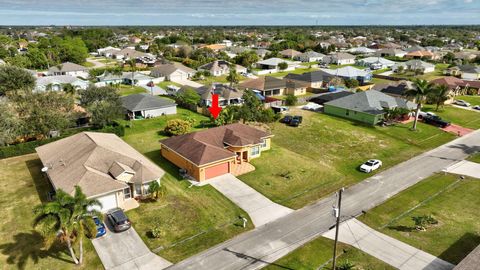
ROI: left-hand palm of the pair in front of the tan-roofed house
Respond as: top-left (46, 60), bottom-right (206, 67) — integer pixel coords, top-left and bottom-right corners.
top-left (33, 190), bottom-right (79, 264)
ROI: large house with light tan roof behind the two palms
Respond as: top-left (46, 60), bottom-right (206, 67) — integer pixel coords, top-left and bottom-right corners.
top-left (36, 132), bottom-right (165, 212)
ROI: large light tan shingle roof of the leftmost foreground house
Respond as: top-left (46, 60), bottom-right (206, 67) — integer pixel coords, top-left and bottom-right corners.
top-left (36, 132), bottom-right (165, 197)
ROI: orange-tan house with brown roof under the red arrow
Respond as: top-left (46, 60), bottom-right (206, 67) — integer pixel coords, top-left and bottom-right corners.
top-left (160, 123), bottom-right (273, 181)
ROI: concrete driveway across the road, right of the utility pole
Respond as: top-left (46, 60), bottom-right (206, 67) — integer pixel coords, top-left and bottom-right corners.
top-left (323, 218), bottom-right (454, 270)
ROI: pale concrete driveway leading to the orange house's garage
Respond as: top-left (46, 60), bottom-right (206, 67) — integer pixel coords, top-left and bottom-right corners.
top-left (208, 174), bottom-right (293, 227)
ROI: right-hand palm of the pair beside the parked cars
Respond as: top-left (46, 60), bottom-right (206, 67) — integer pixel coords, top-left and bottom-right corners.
top-left (73, 186), bottom-right (102, 264)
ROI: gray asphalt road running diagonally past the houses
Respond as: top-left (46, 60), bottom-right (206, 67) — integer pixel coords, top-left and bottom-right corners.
top-left (168, 130), bottom-right (480, 270)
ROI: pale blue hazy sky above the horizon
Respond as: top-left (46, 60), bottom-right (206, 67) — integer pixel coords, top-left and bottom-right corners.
top-left (0, 0), bottom-right (480, 25)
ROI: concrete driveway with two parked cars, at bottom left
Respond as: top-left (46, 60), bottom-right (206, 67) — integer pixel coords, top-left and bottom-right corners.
top-left (92, 222), bottom-right (172, 270)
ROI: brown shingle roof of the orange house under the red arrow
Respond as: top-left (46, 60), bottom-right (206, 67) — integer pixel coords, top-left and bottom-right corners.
top-left (161, 123), bottom-right (271, 166)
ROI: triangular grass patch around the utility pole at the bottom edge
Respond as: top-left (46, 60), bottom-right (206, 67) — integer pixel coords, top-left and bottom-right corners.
top-left (264, 237), bottom-right (395, 270)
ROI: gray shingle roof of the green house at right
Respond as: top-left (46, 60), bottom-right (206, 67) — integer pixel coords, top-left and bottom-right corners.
top-left (325, 90), bottom-right (416, 114)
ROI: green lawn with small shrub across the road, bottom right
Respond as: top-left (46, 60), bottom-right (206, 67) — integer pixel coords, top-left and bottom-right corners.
top-left (359, 174), bottom-right (480, 264)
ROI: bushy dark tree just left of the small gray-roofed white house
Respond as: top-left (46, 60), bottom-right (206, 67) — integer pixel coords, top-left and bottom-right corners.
top-left (80, 86), bottom-right (123, 128)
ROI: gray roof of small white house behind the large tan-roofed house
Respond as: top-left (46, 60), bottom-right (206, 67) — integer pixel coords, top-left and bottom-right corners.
top-left (121, 93), bottom-right (177, 112)
